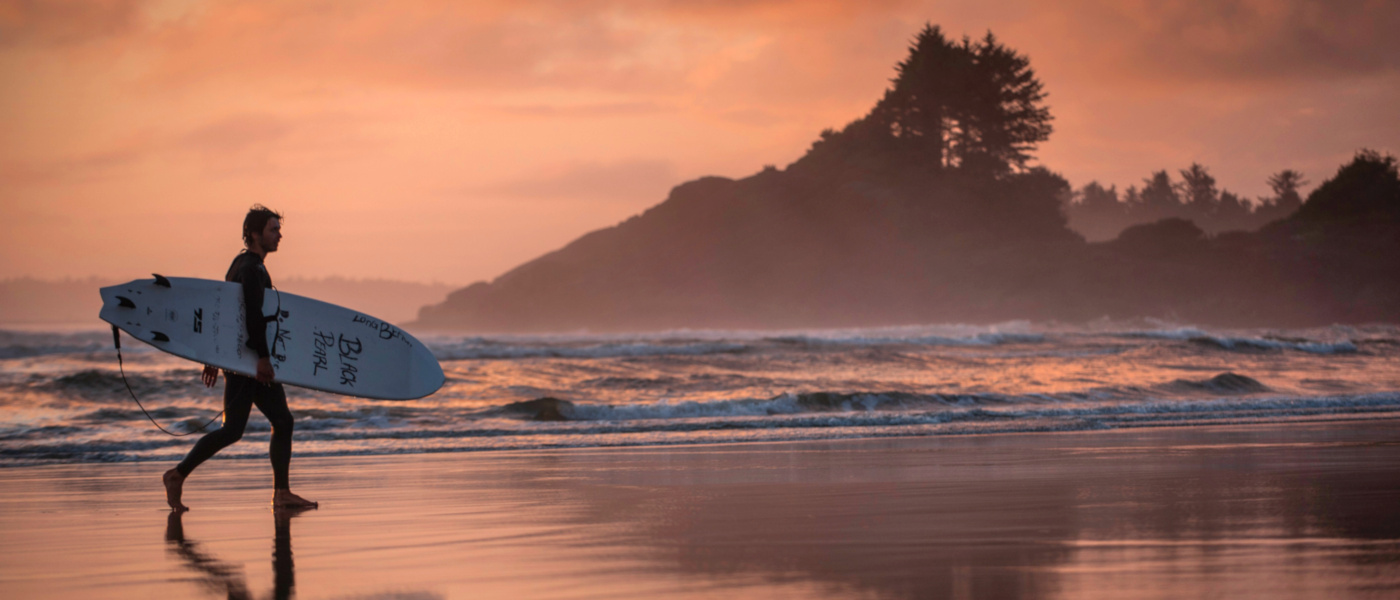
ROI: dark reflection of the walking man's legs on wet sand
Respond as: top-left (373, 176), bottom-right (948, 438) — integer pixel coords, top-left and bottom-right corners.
top-left (165, 508), bottom-right (308, 600)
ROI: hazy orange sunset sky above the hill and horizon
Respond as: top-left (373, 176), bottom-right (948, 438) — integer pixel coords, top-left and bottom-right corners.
top-left (0, 0), bottom-right (1400, 284)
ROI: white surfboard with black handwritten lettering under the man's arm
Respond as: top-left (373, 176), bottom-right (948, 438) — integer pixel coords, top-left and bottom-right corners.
top-left (98, 276), bottom-right (444, 400)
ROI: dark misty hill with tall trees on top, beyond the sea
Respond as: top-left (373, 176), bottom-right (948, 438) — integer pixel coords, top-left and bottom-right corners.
top-left (414, 27), bottom-right (1400, 331)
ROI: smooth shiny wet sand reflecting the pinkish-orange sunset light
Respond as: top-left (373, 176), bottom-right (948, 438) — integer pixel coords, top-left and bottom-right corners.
top-left (0, 420), bottom-right (1400, 599)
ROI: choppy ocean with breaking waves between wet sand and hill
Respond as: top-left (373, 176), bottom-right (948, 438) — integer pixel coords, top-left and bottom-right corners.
top-left (0, 320), bottom-right (1400, 466)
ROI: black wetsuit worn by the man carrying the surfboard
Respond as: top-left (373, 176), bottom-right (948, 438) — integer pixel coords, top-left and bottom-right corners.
top-left (175, 252), bottom-right (291, 490)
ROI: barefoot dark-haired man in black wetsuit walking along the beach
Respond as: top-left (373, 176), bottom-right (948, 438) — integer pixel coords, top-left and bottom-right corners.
top-left (164, 204), bottom-right (316, 510)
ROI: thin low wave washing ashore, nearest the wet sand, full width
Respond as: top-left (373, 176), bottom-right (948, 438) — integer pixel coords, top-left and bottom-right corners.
top-left (0, 393), bottom-right (1400, 464)
